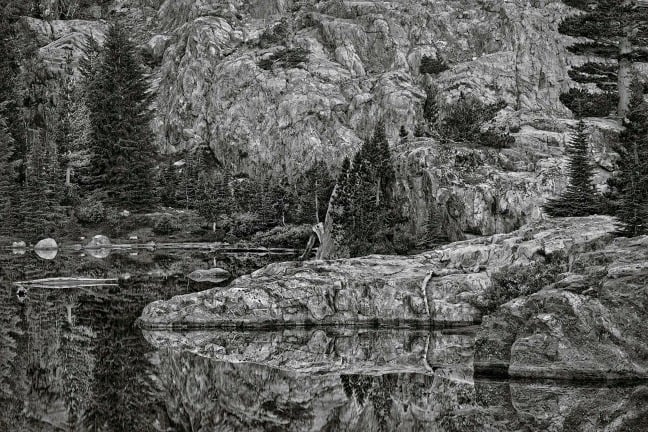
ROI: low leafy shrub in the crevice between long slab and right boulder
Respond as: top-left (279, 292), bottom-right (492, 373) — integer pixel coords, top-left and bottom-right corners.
top-left (481, 253), bottom-right (568, 315)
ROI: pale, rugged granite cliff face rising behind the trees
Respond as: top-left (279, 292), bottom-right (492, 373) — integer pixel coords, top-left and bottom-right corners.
top-left (24, 0), bottom-right (618, 239)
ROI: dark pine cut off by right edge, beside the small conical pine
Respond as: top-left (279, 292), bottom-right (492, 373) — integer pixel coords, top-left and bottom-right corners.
top-left (616, 88), bottom-right (648, 237)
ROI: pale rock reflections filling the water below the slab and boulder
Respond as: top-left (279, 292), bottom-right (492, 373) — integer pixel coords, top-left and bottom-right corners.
top-left (151, 329), bottom-right (648, 432)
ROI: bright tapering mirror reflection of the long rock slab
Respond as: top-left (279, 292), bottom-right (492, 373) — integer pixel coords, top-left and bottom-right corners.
top-left (144, 327), bottom-right (474, 379)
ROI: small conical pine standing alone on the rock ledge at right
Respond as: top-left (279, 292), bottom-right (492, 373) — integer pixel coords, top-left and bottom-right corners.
top-left (544, 119), bottom-right (602, 217)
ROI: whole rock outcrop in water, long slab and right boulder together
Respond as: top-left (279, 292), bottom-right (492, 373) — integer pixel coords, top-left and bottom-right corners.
top-left (141, 216), bottom-right (648, 379)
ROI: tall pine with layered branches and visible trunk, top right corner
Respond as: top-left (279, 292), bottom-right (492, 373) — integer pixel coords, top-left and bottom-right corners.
top-left (558, 0), bottom-right (648, 117)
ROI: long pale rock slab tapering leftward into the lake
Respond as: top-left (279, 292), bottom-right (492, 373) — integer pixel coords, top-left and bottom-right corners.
top-left (141, 217), bottom-right (614, 328)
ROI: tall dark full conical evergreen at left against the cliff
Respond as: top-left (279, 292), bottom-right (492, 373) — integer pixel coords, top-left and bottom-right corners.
top-left (88, 24), bottom-right (156, 209)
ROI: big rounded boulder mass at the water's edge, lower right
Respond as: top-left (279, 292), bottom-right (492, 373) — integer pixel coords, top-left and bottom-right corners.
top-left (475, 237), bottom-right (648, 379)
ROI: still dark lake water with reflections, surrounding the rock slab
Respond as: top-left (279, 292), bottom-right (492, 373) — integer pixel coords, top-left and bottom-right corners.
top-left (0, 251), bottom-right (648, 432)
